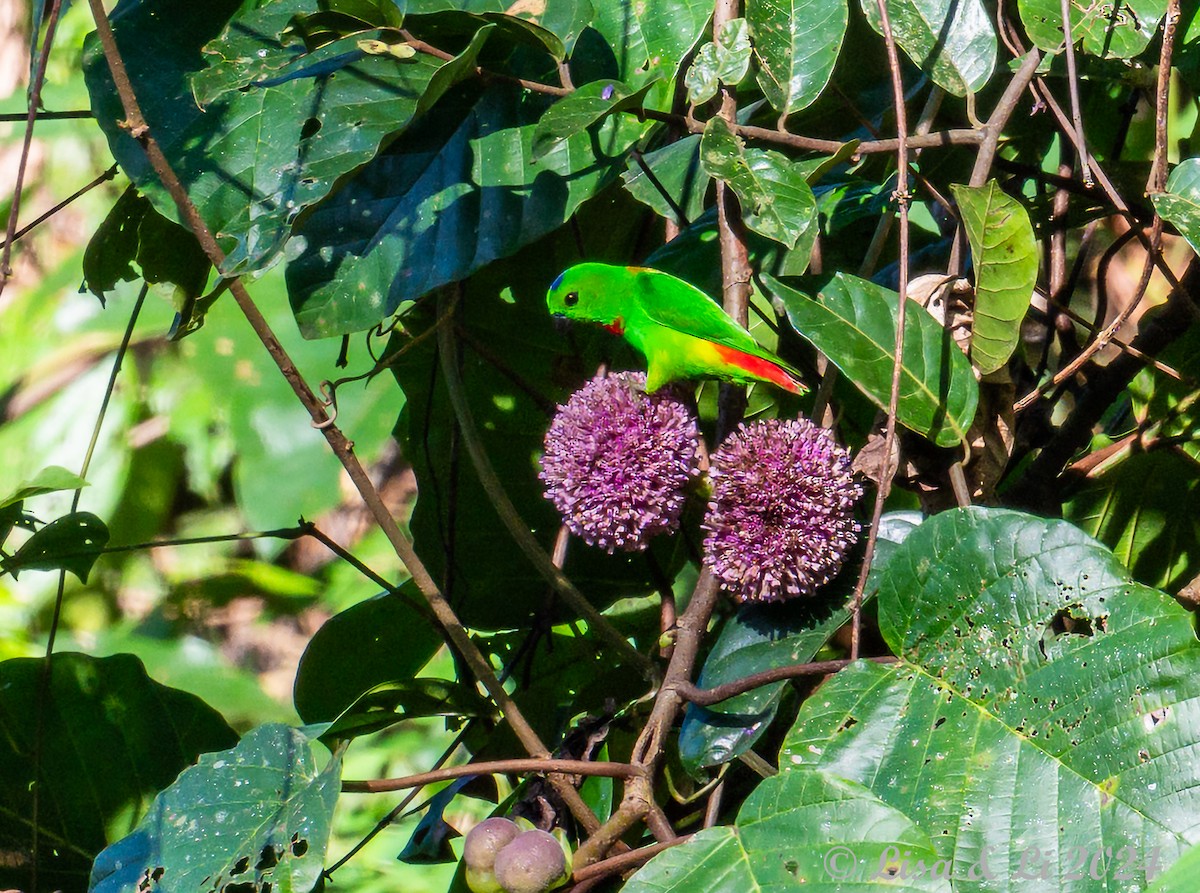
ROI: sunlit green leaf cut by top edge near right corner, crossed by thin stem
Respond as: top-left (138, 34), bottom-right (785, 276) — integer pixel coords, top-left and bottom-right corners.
top-left (1016, 0), bottom-right (1166, 59)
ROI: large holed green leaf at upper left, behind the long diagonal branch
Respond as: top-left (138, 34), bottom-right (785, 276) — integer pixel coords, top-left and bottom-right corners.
top-left (88, 0), bottom-right (490, 272)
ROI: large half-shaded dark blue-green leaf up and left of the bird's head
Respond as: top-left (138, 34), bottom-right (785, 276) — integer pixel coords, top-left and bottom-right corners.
top-left (288, 84), bottom-right (646, 337)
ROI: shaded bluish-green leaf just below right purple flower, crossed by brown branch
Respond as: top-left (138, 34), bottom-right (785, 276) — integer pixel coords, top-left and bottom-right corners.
top-left (679, 511), bottom-right (920, 774)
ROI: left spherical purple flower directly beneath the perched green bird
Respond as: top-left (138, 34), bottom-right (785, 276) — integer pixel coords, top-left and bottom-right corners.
top-left (539, 372), bottom-right (700, 552)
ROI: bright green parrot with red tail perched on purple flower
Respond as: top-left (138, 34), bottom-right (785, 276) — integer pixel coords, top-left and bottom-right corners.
top-left (546, 263), bottom-right (808, 394)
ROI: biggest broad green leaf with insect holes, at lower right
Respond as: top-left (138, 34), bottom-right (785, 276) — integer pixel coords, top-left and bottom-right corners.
top-left (780, 508), bottom-right (1200, 892)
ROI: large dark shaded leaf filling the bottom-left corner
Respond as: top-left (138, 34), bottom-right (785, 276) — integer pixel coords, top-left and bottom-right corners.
top-left (0, 652), bottom-right (236, 891)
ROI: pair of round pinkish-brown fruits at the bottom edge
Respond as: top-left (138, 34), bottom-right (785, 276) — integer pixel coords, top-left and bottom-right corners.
top-left (462, 816), bottom-right (571, 893)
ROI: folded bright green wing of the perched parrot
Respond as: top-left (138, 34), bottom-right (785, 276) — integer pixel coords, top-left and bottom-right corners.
top-left (630, 268), bottom-right (799, 374)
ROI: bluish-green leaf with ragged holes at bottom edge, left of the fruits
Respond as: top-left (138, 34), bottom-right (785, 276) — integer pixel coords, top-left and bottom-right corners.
top-left (89, 724), bottom-right (341, 893)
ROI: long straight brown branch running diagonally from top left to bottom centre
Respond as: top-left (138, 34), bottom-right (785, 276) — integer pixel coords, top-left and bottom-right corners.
top-left (88, 0), bottom-right (599, 828)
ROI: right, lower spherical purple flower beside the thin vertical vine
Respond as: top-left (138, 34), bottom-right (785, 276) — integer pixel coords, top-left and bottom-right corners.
top-left (704, 419), bottom-right (863, 601)
